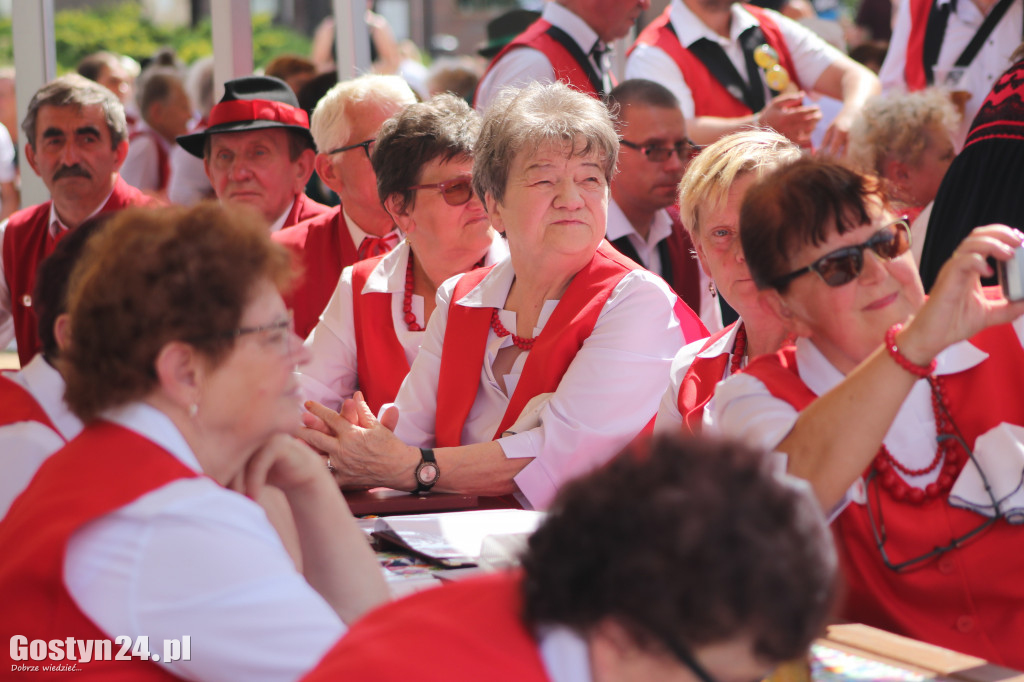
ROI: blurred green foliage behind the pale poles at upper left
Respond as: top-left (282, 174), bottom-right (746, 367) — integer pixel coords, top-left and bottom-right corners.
top-left (0, 2), bottom-right (310, 74)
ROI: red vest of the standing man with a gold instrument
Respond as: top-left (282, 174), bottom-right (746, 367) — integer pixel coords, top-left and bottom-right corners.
top-left (630, 5), bottom-right (801, 118)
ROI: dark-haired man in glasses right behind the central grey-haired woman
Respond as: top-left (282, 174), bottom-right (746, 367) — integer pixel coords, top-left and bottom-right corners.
top-left (606, 79), bottom-right (708, 323)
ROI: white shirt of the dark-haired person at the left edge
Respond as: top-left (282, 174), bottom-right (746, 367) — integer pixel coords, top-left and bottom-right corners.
top-left (0, 354), bottom-right (82, 518)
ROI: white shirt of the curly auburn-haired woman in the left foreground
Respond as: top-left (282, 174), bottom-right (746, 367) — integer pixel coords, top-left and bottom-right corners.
top-left (65, 402), bottom-right (345, 682)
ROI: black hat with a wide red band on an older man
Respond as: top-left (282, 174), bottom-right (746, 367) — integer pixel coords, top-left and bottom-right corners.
top-left (178, 76), bottom-right (315, 159)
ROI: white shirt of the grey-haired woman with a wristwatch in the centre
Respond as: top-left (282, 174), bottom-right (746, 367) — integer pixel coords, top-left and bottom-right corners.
top-left (395, 260), bottom-right (692, 509)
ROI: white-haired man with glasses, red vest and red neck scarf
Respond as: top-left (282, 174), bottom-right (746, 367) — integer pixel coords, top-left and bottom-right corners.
top-left (273, 76), bottom-right (416, 338)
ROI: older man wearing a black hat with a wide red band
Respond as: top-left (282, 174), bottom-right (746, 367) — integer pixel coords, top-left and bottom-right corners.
top-left (178, 76), bottom-right (329, 232)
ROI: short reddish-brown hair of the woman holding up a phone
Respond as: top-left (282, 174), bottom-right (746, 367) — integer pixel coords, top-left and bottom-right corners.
top-left (739, 157), bottom-right (887, 293)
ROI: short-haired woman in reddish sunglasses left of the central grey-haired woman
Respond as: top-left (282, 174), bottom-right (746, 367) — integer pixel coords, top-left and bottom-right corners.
top-left (302, 94), bottom-right (508, 414)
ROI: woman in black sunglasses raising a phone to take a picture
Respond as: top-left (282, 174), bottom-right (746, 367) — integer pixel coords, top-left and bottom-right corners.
top-left (709, 160), bottom-right (1024, 669)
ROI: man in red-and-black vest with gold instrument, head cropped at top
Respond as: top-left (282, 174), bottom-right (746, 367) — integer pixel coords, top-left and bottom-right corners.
top-left (626, 0), bottom-right (880, 156)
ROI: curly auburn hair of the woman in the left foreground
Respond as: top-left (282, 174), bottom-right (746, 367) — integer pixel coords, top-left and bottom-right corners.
top-left (61, 202), bottom-right (293, 421)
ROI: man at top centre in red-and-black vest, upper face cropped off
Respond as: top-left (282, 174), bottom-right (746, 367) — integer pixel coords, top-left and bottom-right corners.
top-left (474, 0), bottom-right (650, 112)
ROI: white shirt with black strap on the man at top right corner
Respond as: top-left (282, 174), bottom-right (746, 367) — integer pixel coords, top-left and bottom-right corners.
top-left (879, 0), bottom-right (1024, 150)
